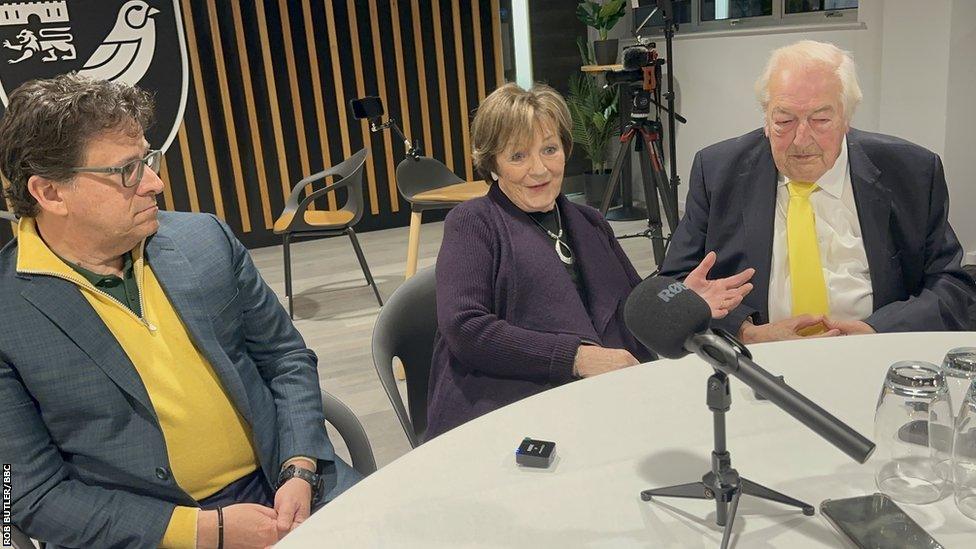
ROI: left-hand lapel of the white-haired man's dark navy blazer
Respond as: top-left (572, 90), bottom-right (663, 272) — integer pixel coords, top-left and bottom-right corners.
top-left (740, 135), bottom-right (776, 321)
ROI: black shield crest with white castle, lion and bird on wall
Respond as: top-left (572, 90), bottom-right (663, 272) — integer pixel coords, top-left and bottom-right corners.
top-left (0, 0), bottom-right (188, 150)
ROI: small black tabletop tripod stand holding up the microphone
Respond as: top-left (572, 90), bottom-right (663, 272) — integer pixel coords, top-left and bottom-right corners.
top-left (641, 364), bottom-right (814, 549)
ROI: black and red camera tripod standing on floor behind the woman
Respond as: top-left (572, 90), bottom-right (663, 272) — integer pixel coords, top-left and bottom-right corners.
top-left (600, 114), bottom-right (678, 265)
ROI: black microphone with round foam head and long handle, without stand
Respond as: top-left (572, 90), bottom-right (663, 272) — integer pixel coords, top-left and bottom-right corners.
top-left (624, 276), bottom-right (874, 463)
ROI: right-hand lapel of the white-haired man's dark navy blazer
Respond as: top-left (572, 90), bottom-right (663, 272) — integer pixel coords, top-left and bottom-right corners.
top-left (847, 130), bottom-right (893, 308)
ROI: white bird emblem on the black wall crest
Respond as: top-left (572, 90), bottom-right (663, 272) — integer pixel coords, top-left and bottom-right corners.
top-left (78, 0), bottom-right (159, 85)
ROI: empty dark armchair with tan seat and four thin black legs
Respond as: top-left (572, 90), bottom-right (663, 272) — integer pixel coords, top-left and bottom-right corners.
top-left (274, 149), bottom-right (383, 318)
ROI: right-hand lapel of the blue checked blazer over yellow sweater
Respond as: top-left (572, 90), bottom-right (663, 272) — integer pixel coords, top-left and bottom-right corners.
top-left (146, 233), bottom-right (253, 423)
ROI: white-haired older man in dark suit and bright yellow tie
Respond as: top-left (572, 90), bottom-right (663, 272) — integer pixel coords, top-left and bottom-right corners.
top-left (661, 41), bottom-right (976, 343)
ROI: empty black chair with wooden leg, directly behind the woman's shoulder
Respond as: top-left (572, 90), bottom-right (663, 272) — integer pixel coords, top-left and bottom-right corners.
top-left (397, 156), bottom-right (488, 278)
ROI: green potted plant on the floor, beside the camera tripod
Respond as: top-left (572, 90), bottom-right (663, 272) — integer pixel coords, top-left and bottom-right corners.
top-left (566, 73), bottom-right (619, 206)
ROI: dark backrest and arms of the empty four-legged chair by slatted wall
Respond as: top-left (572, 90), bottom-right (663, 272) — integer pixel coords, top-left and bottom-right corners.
top-left (281, 148), bottom-right (369, 231)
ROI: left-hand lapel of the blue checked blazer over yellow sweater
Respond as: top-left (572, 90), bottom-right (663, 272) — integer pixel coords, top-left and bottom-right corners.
top-left (21, 276), bottom-right (158, 422)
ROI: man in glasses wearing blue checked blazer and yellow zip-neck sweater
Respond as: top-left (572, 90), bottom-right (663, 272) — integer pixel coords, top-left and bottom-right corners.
top-left (0, 75), bottom-right (359, 548)
